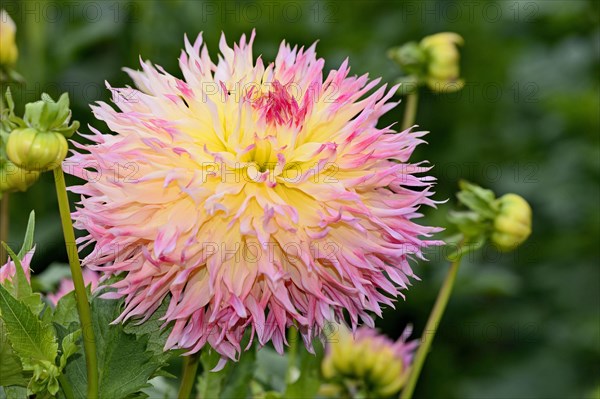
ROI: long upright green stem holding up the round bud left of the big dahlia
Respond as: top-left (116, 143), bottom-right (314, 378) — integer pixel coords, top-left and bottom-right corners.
top-left (54, 166), bottom-right (98, 399)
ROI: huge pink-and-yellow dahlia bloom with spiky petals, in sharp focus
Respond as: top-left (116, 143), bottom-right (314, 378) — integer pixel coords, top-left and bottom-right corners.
top-left (63, 32), bottom-right (437, 360)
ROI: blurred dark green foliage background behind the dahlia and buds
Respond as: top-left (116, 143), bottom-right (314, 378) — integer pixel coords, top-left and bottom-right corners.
top-left (1, 0), bottom-right (600, 398)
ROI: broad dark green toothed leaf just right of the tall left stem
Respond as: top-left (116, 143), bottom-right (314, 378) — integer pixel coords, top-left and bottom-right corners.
top-left (92, 297), bottom-right (164, 399)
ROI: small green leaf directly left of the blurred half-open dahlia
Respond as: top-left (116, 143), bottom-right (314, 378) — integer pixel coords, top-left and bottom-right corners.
top-left (283, 342), bottom-right (323, 399)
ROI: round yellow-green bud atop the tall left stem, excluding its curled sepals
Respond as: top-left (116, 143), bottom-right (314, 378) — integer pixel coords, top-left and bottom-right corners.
top-left (6, 128), bottom-right (69, 171)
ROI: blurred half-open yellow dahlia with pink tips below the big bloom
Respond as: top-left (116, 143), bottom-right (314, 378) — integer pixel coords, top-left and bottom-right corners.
top-left (321, 326), bottom-right (418, 397)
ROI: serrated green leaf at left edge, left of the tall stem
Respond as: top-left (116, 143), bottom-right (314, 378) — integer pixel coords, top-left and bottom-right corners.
top-left (0, 285), bottom-right (58, 370)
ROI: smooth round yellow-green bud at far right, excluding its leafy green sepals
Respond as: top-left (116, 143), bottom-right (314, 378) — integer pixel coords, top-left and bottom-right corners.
top-left (492, 194), bottom-right (531, 251)
